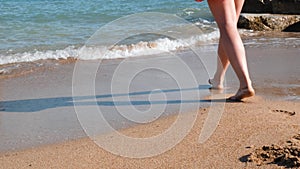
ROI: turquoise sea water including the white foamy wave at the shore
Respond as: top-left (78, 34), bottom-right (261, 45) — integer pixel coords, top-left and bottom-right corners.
top-left (0, 0), bottom-right (300, 67)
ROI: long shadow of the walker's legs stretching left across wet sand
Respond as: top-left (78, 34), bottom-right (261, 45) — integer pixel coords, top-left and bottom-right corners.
top-left (0, 85), bottom-right (238, 112)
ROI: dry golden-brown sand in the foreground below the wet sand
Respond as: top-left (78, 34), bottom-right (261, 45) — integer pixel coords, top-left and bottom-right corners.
top-left (0, 97), bottom-right (300, 168)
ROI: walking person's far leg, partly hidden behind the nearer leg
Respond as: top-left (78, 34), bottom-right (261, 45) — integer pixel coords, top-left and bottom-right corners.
top-left (209, 0), bottom-right (244, 89)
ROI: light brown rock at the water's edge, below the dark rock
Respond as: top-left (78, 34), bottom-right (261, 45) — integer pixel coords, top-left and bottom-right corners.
top-left (238, 13), bottom-right (300, 31)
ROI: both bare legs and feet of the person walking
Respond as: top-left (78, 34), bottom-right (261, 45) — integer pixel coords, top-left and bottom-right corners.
top-left (208, 0), bottom-right (255, 100)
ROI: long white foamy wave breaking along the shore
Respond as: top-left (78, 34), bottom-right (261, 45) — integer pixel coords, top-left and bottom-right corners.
top-left (0, 31), bottom-right (219, 65)
